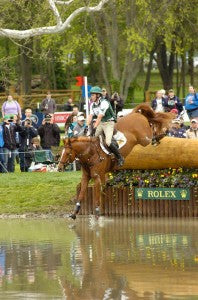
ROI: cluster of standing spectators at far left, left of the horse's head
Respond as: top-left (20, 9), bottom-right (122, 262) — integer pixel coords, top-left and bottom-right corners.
top-left (0, 92), bottom-right (60, 173)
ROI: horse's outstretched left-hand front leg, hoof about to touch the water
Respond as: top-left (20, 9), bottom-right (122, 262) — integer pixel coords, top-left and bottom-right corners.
top-left (70, 170), bottom-right (90, 220)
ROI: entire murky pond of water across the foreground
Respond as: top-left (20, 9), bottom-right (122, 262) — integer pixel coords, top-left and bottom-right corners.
top-left (0, 218), bottom-right (198, 300)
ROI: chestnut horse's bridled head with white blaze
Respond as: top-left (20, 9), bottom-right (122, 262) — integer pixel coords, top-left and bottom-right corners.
top-left (58, 139), bottom-right (76, 171)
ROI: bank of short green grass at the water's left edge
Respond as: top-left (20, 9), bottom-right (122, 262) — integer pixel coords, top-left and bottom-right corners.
top-left (0, 171), bottom-right (81, 214)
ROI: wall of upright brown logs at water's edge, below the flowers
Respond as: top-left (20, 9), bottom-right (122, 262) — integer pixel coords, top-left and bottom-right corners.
top-left (81, 186), bottom-right (198, 218)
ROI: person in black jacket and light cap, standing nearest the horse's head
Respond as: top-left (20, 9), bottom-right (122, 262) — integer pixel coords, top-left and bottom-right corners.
top-left (38, 115), bottom-right (60, 160)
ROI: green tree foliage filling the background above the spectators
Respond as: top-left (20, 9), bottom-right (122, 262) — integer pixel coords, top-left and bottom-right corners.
top-left (0, 0), bottom-right (198, 98)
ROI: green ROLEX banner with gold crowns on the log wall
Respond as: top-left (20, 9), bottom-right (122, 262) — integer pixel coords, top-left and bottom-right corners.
top-left (135, 188), bottom-right (190, 200)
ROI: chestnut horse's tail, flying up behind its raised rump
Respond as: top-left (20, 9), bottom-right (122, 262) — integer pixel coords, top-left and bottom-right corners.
top-left (133, 103), bottom-right (174, 133)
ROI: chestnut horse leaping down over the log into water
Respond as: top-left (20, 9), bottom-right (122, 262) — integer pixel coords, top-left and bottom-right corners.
top-left (58, 104), bottom-right (173, 219)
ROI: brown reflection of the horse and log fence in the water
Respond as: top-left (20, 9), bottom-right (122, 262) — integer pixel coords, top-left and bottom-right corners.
top-left (57, 218), bottom-right (198, 300)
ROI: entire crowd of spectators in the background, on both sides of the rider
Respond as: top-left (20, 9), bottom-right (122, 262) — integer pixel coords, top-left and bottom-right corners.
top-left (0, 86), bottom-right (198, 173)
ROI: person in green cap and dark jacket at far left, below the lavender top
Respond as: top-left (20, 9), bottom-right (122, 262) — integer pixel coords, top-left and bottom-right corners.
top-left (3, 115), bottom-right (22, 172)
